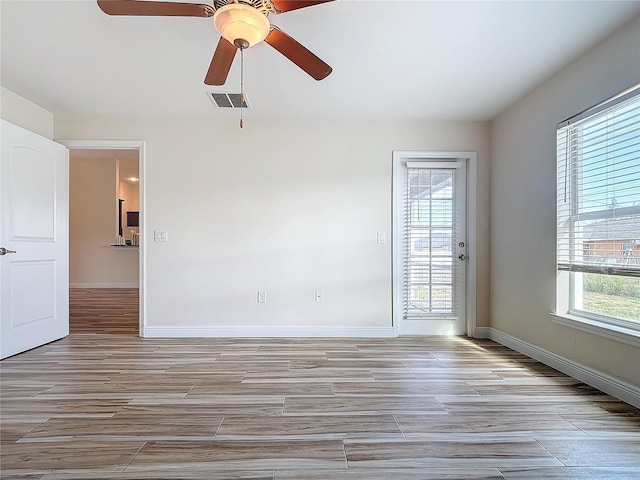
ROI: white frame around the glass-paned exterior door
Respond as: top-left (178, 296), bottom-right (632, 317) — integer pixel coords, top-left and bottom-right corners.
top-left (391, 150), bottom-right (478, 338)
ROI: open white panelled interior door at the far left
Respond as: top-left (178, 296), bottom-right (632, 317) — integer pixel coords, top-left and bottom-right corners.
top-left (0, 120), bottom-right (69, 358)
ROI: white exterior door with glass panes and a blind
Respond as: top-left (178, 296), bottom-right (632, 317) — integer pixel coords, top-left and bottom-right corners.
top-left (394, 152), bottom-right (468, 335)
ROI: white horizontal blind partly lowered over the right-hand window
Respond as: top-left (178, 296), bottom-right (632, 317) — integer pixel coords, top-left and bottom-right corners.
top-left (557, 87), bottom-right (640, 277)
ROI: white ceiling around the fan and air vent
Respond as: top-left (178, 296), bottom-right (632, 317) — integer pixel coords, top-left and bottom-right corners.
top-left (0, 0), bottom-right (640, 120)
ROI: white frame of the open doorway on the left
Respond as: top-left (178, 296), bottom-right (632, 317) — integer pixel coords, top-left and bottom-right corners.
top-left (56, 140), bottom-right (147, 337)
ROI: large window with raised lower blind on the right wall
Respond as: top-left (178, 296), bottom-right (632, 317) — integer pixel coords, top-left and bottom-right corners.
top-left (556, 87), bottom-right (640, 332)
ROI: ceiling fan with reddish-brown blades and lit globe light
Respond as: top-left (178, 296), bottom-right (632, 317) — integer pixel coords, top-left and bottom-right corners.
top-left (97, 0), bottom-right (333, 85)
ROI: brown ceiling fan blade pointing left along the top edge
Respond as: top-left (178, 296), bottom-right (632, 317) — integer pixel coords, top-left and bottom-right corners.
top-left (98, 0), bottom-right (215, 17)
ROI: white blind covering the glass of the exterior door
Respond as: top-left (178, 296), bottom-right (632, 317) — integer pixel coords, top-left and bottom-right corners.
top-left (403, 164), bottom-right (456, 319)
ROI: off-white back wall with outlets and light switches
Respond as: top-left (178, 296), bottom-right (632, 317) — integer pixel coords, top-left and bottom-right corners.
top-left (56, 117), bottom-right (489, 335)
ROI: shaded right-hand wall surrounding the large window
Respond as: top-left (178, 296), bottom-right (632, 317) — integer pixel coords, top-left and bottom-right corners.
top-left (491, 18), bottom-right (640, 385)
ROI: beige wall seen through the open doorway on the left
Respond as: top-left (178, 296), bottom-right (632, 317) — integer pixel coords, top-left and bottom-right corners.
top-left (69, 154), bottom-right (139, 288)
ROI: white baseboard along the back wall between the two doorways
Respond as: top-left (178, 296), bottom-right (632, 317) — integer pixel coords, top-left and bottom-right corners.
top-left (144, 326), bottom-right (393, 338)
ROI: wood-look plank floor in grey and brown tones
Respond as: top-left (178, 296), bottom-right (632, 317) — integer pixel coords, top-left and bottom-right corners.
top-left (0, 289), bottom-right (640, 480)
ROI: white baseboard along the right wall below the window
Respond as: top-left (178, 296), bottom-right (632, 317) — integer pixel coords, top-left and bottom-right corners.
top-left (476, 327), bottom-right (640, 408)
